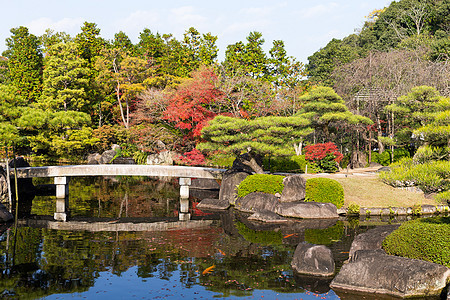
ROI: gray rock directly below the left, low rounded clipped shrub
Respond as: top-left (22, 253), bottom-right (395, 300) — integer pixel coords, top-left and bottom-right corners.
top-left (235, 192), bottom-right (278, 212)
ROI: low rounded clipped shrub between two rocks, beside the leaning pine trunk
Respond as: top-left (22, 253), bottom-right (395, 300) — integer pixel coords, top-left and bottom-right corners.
top-left (238, 174), bottom-right (284, 197)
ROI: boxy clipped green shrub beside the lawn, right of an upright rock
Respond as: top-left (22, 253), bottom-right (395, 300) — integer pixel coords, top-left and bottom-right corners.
top-left (305, 178), bottom-right (344, 208)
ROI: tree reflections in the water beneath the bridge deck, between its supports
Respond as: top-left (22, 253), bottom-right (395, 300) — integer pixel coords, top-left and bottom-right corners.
top-left (32, 177), bottom-right (179, 218)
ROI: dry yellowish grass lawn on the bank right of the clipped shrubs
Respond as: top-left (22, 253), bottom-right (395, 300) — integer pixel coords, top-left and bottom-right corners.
top-left (305, 175), bottom-right (440, 207)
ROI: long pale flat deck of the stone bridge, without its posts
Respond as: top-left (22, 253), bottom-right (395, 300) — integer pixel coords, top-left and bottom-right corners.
top-left (17, 165), bottom-right (225, 179)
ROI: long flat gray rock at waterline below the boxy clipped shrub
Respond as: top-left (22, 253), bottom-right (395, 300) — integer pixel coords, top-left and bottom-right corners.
top-left (275, 202), bottom-right (339, 219)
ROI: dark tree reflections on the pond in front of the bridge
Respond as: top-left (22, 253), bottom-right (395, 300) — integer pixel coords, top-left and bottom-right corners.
top-left (0, 213), bottom-right (368, 298)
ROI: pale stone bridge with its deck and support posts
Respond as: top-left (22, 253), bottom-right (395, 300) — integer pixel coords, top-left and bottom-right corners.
top-left (17, 165), bottom-right (225, 221)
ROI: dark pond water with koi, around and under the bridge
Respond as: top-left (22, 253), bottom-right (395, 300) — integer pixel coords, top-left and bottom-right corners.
top-left (0, 177), bottom-right (414, 299)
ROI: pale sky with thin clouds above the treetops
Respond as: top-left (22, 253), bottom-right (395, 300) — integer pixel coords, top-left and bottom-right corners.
top-left (0, 0), bottom-right (392, 64)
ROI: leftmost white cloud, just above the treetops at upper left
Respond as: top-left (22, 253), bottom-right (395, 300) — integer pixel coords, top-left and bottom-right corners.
top-left (27, 18), bottom-right (85, 35)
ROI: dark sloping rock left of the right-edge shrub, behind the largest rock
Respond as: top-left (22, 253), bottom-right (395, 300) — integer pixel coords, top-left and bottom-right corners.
top-left (348, 225), bottom-right (400, 259)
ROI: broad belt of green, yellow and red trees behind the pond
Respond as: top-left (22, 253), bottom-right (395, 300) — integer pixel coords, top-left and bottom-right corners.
top-left (0, 0), bottom-right (450, 173)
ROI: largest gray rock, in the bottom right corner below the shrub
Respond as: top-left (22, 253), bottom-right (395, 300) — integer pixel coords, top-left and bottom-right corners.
top-left (330, 250), bottom-right (450, 298)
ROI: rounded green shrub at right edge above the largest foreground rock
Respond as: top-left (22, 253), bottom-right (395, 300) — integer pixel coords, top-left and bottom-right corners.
top-left (383, 217), bottom-right (450, 267)
